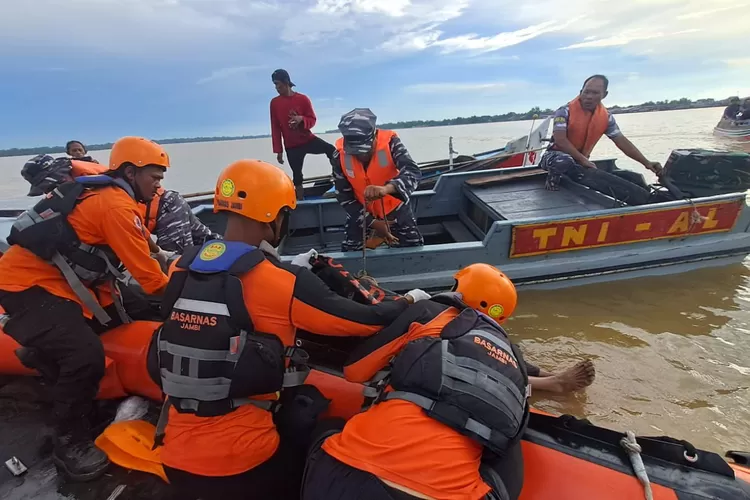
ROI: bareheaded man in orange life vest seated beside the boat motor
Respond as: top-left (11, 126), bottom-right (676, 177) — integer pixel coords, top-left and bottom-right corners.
top-left (539, 75), bottom-right (661, 191)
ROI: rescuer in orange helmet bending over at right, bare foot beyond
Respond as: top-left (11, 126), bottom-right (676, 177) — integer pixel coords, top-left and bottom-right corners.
top-left (302, 264), bottom-right (540, 500)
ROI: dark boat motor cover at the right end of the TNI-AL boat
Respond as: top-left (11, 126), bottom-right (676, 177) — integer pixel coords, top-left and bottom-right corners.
top-left (664, 149), bottom-right (750, 197)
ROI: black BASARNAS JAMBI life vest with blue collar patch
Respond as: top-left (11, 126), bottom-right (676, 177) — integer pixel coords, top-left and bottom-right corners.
top-left (148, 240), bottom-right (309, 420)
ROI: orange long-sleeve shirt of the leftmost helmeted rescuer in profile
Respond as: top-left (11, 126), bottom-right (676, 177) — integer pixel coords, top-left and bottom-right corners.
top-left (0, 186), bottom-right (168, 318)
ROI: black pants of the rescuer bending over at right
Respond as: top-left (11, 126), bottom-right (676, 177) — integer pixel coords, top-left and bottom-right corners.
top-left (302, 436), bottom-right (523, 500)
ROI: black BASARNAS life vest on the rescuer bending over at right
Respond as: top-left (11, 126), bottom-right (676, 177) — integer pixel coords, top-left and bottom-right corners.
top-left (377, 294), bottom-right (529, 456)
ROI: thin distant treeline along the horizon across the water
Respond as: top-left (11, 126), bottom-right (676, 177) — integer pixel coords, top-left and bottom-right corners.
top-left (0, 97), bottom-right (729, 156)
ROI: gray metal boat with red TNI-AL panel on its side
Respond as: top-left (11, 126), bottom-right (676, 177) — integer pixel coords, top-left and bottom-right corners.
top-left (187, 160), bottom-right (750, 291)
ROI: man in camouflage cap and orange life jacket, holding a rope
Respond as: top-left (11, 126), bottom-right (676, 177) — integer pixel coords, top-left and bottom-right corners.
top-left (331, 108), bottom-right (424, 252)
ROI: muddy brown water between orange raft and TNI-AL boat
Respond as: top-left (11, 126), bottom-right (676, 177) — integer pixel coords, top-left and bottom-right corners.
top-left (508, 264), bottom-right (750, 454)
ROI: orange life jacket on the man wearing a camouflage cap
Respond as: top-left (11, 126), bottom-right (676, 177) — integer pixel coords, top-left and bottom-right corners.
top-left (336, 129), bottom-right (402, 219)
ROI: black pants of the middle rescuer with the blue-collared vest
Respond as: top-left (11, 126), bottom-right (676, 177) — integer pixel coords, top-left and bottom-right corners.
top-left (164, 439), bottom-right (302, 500)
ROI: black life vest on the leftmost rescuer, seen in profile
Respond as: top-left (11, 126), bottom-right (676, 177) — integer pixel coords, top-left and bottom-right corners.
top-left (8, 175), bottom-right (135, 324)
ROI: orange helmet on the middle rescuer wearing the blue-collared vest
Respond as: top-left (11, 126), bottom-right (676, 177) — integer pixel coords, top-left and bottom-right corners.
top-left (214, 160), bottom-right (297, 223)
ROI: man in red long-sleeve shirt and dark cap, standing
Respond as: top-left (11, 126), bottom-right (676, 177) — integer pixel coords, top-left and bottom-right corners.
top-left (271, 69), bottom-right (336, 200)
